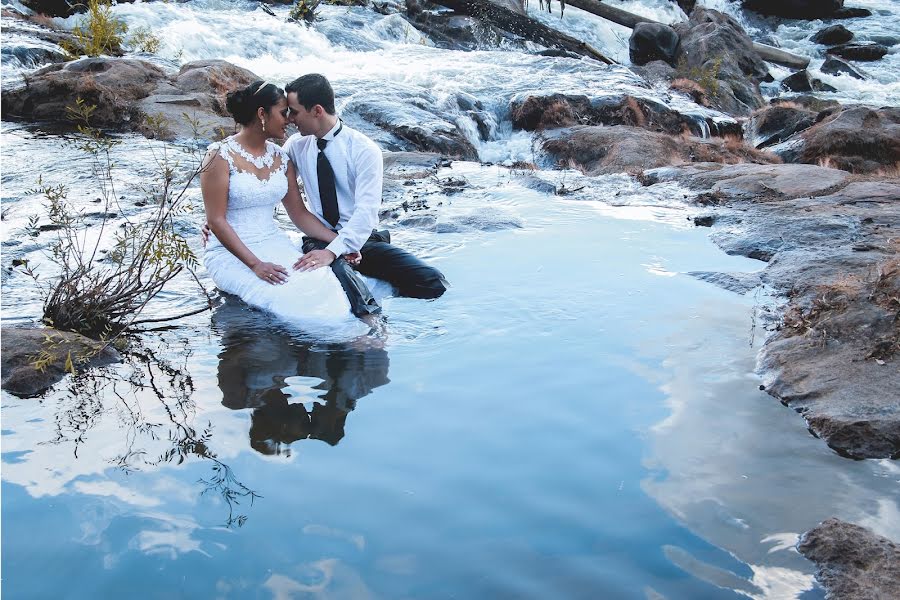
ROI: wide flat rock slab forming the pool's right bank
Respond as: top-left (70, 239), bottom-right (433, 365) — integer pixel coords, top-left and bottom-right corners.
top-left (645, 164), bottom-right (900, 458)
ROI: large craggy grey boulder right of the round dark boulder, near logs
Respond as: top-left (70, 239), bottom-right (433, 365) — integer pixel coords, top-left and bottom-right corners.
top-left (675, 8), bottom-right (771, 116)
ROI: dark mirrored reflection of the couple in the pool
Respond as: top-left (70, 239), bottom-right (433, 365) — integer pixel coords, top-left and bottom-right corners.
top-left (213, 297), bottom-right (390, 456)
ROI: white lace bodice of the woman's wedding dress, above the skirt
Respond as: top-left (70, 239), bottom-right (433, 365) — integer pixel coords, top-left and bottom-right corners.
top-left (209, 137), bottom-right (288, 245)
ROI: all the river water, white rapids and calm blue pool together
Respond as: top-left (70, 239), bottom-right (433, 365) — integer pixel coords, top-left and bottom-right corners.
top-left (0, 1), bottom-right (900, 598)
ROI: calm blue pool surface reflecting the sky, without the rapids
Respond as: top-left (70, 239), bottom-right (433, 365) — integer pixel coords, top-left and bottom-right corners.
top-left (3, 158), bottom-right (897, 598)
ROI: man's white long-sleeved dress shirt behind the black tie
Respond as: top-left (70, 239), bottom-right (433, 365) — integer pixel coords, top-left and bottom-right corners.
top-left (284, 121), bottom-right (384, 256)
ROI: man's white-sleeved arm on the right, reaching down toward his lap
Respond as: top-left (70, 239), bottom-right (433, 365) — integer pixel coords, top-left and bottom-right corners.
top-left (327, 142), bottom-right (384, 256)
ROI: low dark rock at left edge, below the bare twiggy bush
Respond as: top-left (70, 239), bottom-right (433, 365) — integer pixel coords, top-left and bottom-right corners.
top-left (0, 327), bottom-right (122, 397)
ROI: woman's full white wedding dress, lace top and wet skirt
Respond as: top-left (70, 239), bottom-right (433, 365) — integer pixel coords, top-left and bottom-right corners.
top-left (203, 137), bottom-right (376, 335)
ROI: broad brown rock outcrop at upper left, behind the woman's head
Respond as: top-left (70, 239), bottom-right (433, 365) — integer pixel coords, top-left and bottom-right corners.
top-left (2, 57), bottom-right (259, 140)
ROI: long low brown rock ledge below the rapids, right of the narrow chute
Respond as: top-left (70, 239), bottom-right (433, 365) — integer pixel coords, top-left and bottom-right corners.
top-left (510, 94), bottom-right (740, 135)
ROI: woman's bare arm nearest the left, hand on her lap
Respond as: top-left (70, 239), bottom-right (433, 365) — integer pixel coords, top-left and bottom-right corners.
top-left (200, 150), bottom-right (288, 284)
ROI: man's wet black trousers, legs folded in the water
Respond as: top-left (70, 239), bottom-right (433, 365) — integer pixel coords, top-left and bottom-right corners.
top-left (303, 231), bottom-right (449, 317)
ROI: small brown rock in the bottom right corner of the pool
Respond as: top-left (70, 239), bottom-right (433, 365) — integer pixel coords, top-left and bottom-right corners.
top-left (797, 518), bottom-right (900, 600)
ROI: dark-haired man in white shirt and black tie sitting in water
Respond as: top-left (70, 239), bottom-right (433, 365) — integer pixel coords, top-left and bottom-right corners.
top-left (284, 74), bottom-right (448, 316)
